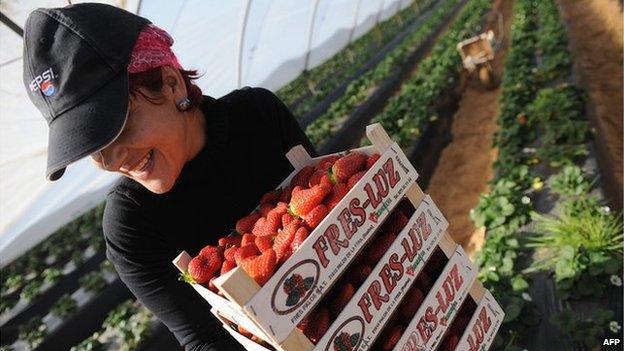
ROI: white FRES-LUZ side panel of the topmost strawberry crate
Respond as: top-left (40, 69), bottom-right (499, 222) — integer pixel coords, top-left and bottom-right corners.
top-left (245, 143), bottom-right (418, 342)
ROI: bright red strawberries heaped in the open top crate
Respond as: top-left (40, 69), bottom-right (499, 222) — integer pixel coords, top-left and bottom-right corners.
top-left (182, 152), bottom-right (380, 292)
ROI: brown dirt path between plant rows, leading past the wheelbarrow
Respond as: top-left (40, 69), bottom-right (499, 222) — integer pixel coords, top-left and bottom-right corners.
top-left (427, 0), bottom-right (513, 254)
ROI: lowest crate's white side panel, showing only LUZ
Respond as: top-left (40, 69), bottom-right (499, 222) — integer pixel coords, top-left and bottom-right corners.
top-left (456, 291), bottom-right (505, 351)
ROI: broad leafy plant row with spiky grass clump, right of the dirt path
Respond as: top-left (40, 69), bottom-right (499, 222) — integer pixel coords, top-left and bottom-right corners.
top-left (471, 0), bottom-right (622, 350)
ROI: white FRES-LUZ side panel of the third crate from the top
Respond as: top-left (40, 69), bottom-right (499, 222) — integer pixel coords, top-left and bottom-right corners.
top-left (394, 245), bottom-right (477, 351)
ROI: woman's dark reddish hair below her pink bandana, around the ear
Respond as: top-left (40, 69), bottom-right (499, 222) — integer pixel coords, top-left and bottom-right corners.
top-left (128, 67), bottom-right (202, 108)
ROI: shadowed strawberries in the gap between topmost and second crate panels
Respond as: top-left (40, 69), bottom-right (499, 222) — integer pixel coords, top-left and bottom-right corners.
top-left (297, 199), bottom-right (414, 344)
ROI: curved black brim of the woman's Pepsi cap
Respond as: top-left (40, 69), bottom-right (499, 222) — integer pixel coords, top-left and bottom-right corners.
top-left (46, 71), bottom-right (129, 181)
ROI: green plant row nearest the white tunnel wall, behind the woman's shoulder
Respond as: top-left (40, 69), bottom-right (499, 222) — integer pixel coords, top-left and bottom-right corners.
top-left (276, 0), bottom-right (432, 117)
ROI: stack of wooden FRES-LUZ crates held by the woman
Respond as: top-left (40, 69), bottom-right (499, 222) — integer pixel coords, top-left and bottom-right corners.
top-left (173, 124), bottom-right (504, 351)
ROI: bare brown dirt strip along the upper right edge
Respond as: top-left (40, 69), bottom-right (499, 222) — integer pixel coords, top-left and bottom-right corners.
top-left (559, 0), bottom-right (623, 210)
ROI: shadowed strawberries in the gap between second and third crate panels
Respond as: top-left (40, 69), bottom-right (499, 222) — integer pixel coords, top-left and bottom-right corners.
top-left (371, 249), bottom-right (452, 351)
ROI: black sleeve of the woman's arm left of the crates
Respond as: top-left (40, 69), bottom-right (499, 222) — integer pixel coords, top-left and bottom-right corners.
top-left (103, 192), bottom-right (243, 351)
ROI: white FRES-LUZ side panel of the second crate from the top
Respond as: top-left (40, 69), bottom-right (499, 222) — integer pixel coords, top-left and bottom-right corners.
top-left (314, 196), bottom-right (448, 351)
